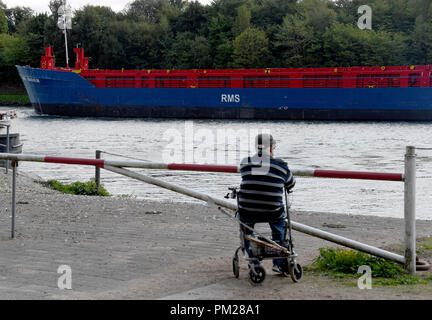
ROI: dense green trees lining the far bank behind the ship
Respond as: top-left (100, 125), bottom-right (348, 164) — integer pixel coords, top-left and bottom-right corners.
top-left (0, 0), bottom-right (432, 83)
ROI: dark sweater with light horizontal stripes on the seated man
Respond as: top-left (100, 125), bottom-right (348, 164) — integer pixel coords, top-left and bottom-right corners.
top-left (238, 155), bottom-right (295, 218)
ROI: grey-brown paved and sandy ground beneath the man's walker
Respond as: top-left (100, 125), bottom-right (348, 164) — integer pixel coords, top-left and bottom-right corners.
top-left (0, 169), bottom-right (432, 299)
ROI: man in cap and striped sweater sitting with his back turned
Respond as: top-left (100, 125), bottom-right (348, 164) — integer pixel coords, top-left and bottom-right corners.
top-left (238, 134), bottom-right (295, 273)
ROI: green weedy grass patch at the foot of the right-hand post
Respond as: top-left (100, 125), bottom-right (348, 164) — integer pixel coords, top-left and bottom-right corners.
top-left (305, 248), bottom-right (432, 286)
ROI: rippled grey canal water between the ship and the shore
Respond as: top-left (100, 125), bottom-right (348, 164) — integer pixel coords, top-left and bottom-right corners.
top-left (3, 108), bottom-right (432, 219)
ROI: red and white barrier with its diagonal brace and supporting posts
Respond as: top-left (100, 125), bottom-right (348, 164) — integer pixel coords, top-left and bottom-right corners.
top-left (0, 147), bottom-right (416, 274)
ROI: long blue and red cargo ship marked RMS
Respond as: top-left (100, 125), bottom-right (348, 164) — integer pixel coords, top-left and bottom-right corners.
top-left (17, 47), bottom-right (432, 121)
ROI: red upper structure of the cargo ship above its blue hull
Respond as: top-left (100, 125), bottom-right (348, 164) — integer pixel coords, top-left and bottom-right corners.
top-left (41, 47), bottom-right (432, 88)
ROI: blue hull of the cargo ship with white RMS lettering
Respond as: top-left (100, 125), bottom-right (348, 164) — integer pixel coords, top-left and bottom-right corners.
top-left (17, 66), bottom-right (432, 121)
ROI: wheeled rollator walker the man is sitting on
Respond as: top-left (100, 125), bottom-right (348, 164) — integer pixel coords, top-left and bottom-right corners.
top-left (219, 187), bottom-right (303, 284)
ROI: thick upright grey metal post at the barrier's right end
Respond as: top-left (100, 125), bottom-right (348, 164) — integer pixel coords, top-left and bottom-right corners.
top-left (404, 146), bottom-right (416, 275)
